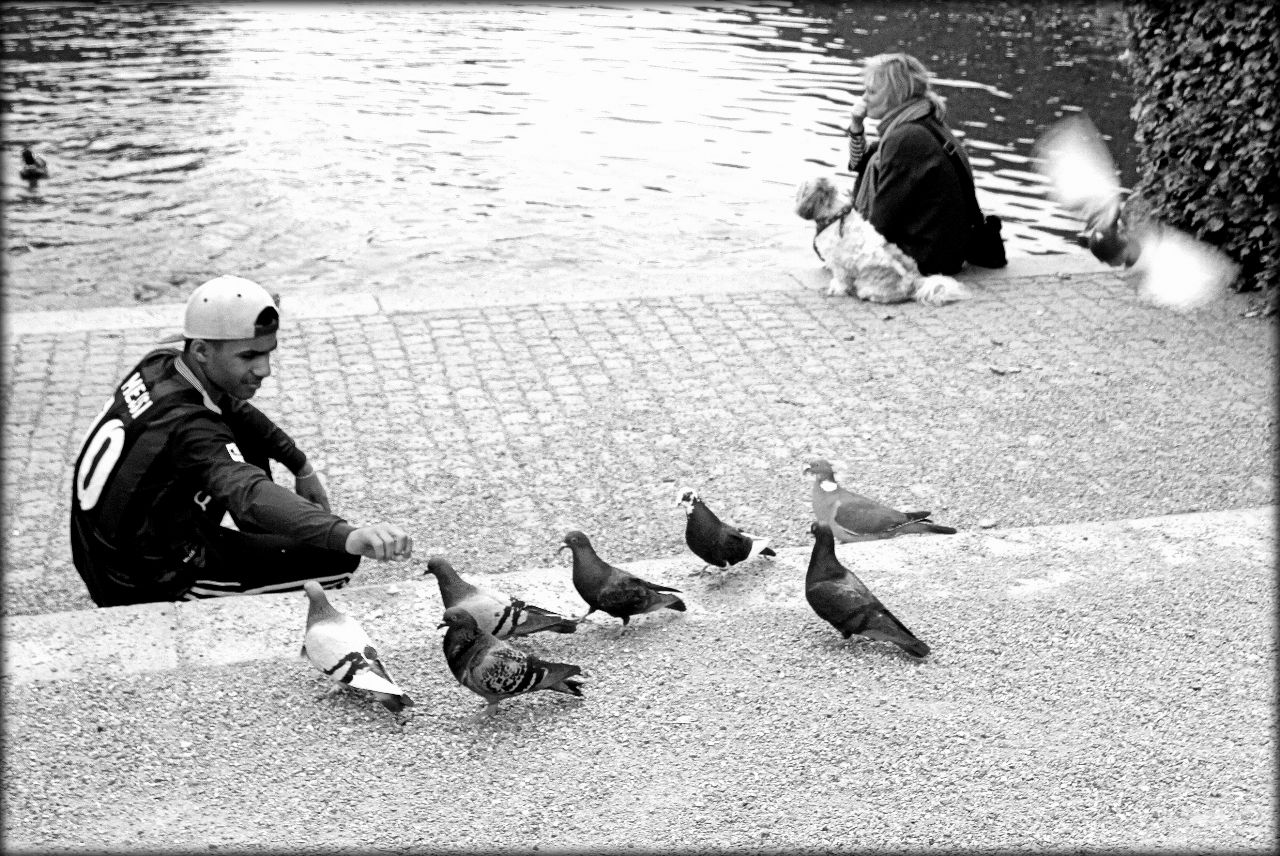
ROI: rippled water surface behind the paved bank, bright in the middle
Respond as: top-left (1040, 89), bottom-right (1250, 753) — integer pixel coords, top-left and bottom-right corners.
top-left (3, 3), bottom-right (1133, 310)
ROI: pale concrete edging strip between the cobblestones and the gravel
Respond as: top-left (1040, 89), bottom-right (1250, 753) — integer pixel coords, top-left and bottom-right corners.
top-left (4, 505), bottom-right (1277, 683)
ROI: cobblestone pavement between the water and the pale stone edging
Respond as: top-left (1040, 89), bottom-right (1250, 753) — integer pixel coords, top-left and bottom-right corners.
top-left (3, 261), bottom-right (1276, 615)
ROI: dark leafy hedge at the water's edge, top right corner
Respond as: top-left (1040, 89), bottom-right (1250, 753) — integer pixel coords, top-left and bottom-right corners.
top-left (1123, 0), bottom-right (1280, 308)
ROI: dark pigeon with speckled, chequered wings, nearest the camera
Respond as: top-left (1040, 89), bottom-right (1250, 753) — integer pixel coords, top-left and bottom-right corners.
top-left (439, 606), bottom-right (582, 715)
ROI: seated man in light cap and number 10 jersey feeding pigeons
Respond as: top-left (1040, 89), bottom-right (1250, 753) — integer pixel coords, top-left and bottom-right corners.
top-left (70, 269), bottom-right (412, 606)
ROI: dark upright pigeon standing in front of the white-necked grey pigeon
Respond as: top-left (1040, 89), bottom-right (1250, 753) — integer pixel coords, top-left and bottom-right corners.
top-left (804, 522), bottom-right (929, 658)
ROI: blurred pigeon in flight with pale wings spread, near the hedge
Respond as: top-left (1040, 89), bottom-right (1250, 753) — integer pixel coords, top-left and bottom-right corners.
top-left (1036, 113), bottom-right (1238, 310)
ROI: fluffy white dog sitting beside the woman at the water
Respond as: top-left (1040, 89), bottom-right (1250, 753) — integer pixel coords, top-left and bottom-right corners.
top-left (796, 175), bottom-right (972, 306)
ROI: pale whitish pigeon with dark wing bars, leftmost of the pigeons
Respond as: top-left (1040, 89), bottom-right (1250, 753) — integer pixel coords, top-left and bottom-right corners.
top-left (302, 580), bottom-right (413, 714)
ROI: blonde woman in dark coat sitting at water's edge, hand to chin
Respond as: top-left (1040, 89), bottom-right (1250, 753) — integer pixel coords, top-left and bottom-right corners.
top-left (846, 54), bottom-right (980, 275)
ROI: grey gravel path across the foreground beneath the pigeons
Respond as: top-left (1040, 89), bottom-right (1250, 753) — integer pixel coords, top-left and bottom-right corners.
top-left (4, 513), bottom-right (1276, 852)
